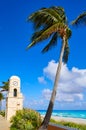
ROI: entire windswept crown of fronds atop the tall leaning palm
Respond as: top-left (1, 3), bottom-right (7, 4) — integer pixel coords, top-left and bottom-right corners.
top-left (26, 6), bottom-right (71, 63)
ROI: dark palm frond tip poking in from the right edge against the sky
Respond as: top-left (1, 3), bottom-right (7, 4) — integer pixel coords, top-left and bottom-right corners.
top-left (72, 11), bottom-right (86, 26)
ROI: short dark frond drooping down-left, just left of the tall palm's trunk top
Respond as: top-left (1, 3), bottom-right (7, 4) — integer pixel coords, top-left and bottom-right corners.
top-left (42, 32), bottom-right (58, 53)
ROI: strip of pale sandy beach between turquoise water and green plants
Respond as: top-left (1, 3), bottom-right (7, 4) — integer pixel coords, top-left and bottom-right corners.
top-left (42, 116), bottom-right (86, 124)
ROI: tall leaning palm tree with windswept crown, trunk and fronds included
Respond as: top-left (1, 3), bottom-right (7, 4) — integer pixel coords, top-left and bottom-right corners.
top-left (27, 7), bottom-right (71, 130)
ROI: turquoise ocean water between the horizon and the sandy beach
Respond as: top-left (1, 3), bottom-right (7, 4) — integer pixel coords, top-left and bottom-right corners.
top-left (37, 110), bottom-right (86, 119)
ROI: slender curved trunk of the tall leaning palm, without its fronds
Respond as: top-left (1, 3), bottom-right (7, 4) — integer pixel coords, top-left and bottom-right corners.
top-left (38, 36), bottom-right (66, 130)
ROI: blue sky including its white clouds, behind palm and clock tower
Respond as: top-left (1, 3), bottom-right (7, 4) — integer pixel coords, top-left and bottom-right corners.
top-left (0, 0), bottom-right (86, 109)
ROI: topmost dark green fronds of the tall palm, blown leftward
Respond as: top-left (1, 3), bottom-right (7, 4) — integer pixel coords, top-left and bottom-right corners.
top-left (28, 7), bottom-right (64, 29)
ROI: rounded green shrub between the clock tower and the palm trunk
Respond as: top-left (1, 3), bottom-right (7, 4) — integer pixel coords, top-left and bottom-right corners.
top-left (10, 109), bottom-right (41, 130)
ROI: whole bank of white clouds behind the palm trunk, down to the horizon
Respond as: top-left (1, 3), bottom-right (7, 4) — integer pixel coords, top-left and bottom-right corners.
top-left (24, 60), bottom-right (86, 110)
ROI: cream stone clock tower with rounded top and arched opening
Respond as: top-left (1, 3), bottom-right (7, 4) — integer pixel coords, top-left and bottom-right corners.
top-left (6, 76), bottom-right (23, 120)
